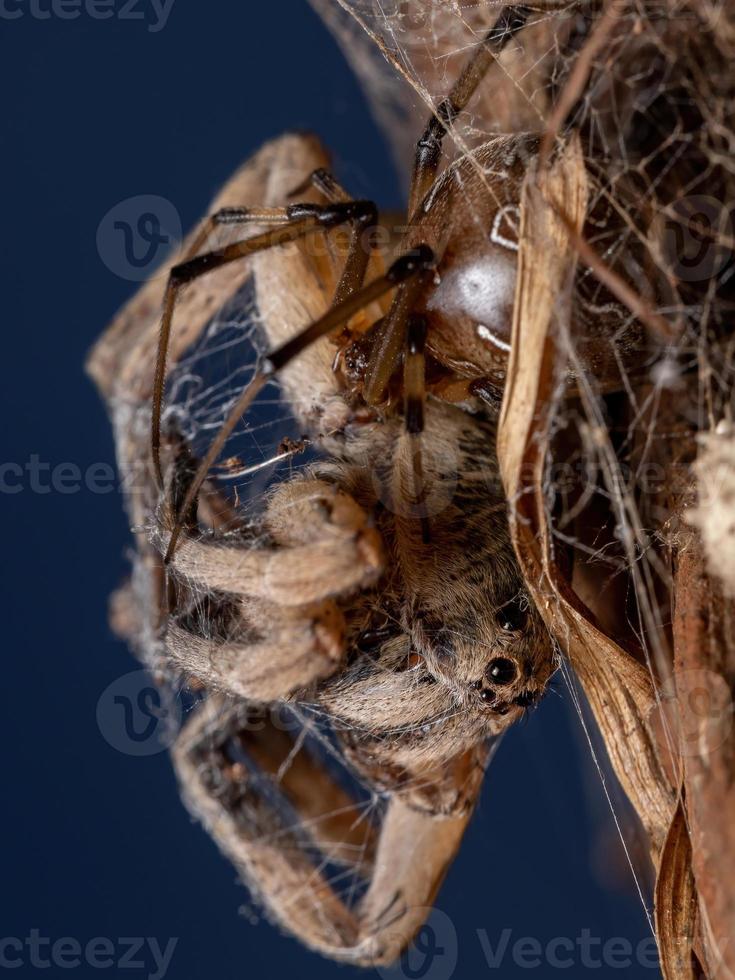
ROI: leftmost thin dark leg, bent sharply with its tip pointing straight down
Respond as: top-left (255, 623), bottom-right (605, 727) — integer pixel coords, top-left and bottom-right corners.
top-left (151, 201), bottom-right (375, 489)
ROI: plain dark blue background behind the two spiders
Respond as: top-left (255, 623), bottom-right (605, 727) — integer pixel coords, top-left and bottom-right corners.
top-left (0, 0), bottom-right (658, 980)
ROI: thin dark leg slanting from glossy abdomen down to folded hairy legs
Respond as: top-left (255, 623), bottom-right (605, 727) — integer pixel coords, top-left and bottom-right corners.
top-left (164, 245), bottom-right (434, 563)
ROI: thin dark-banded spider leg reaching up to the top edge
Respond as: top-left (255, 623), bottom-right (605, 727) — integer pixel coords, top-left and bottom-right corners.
top-left (408, 4), bottom-right (531, 217)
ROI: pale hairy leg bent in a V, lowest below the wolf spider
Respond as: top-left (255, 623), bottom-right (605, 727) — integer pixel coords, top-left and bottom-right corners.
top-left (175, 699), bottom-right (474, 966)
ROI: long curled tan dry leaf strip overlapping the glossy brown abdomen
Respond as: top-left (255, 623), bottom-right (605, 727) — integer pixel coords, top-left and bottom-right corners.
top-left (498, 139), bottom-right (673, 856)
